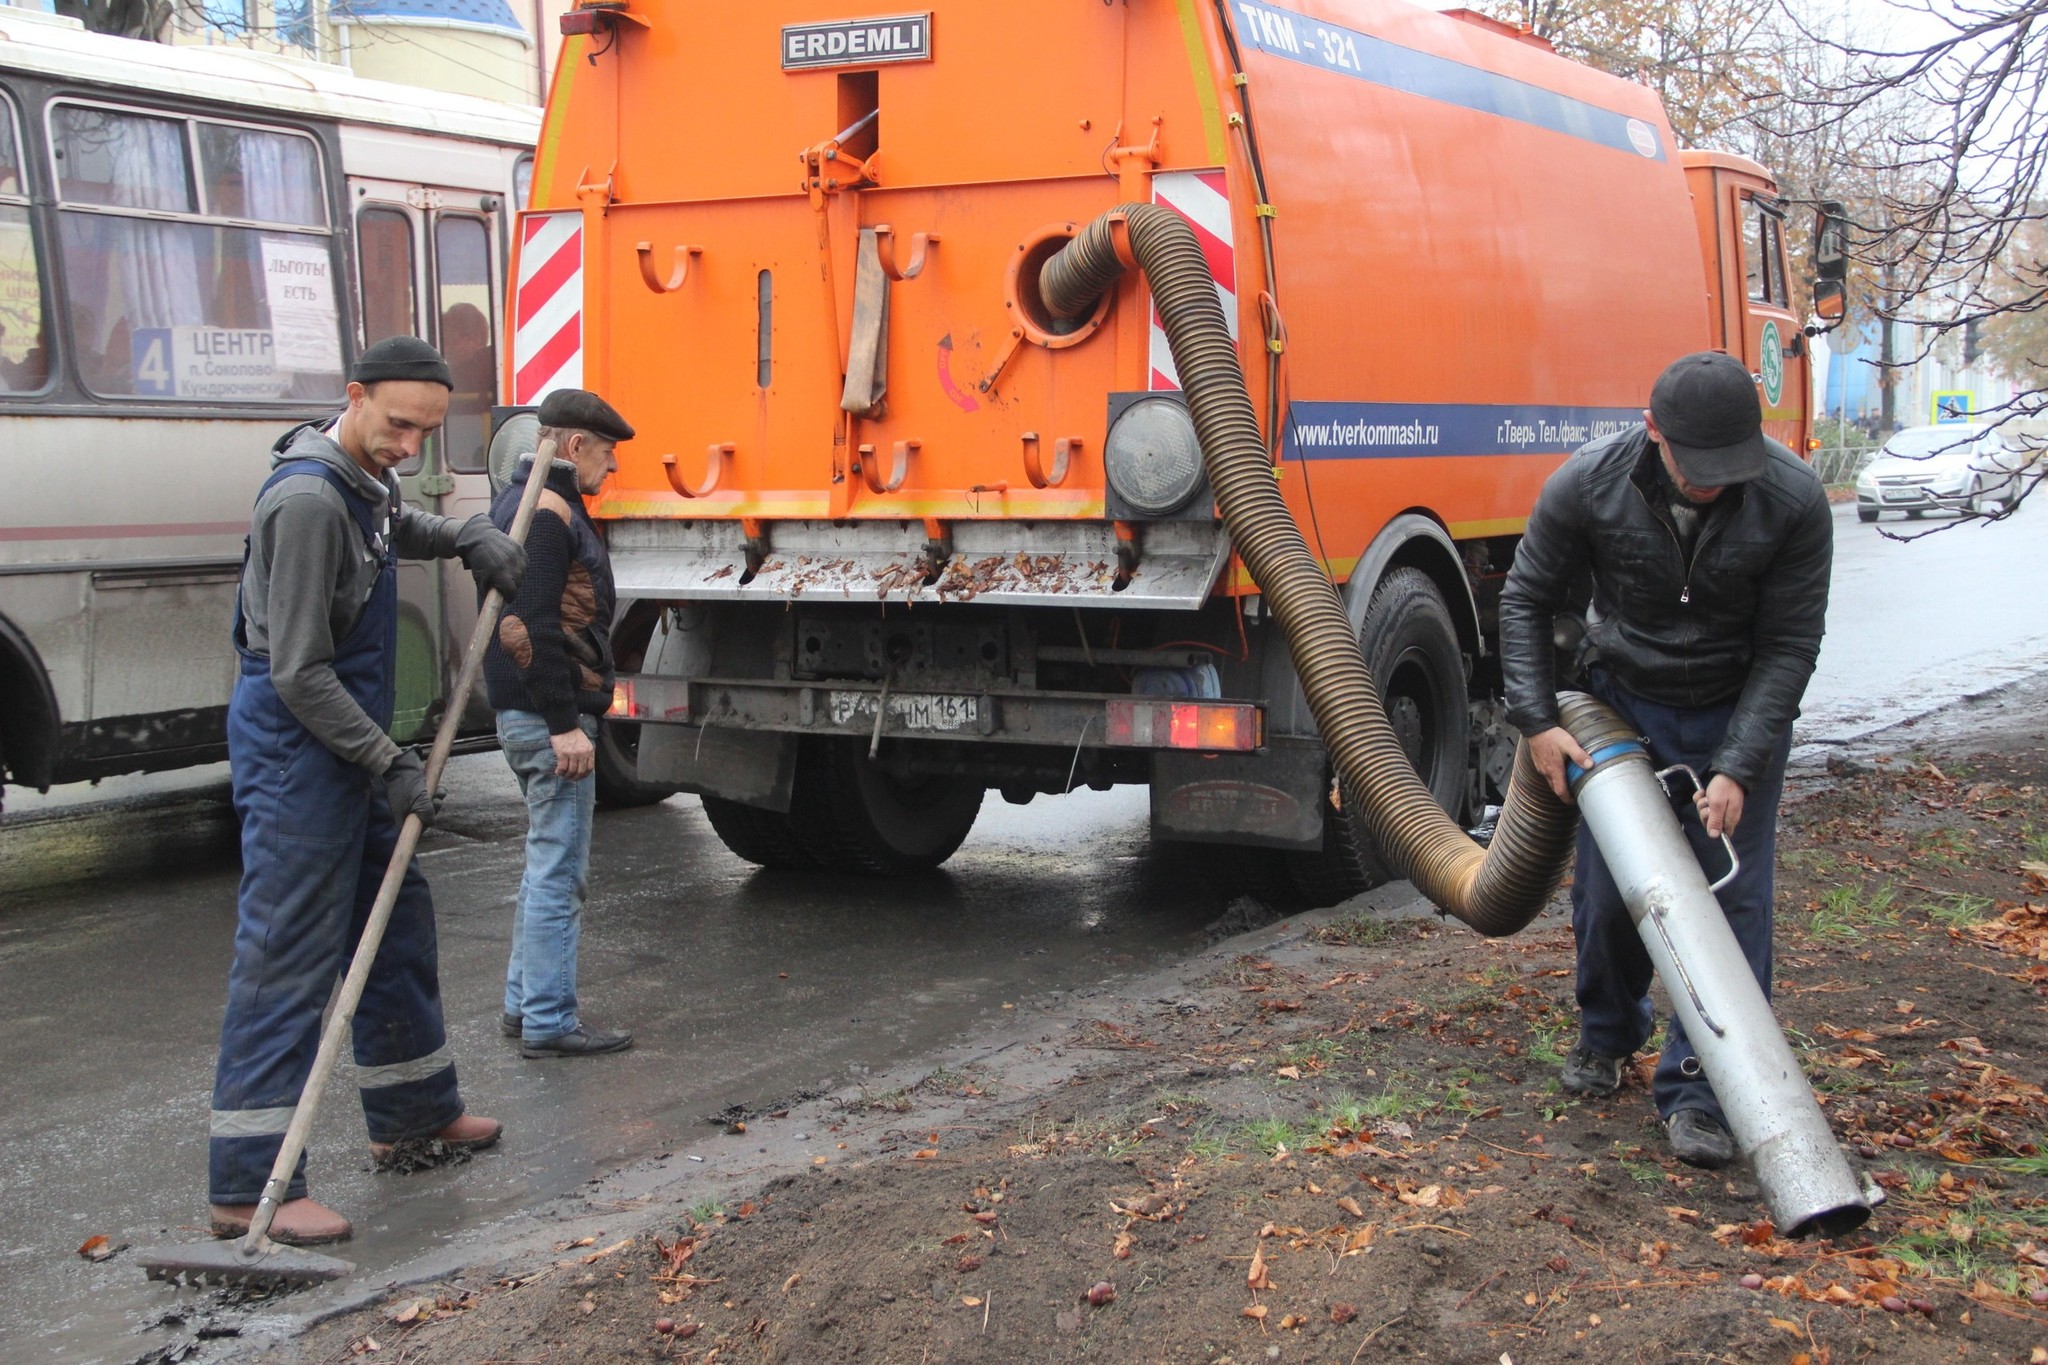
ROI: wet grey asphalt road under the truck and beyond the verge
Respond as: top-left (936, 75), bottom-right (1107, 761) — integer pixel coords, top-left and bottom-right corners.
top-left (0, 493), bottom-right (2048, 1361)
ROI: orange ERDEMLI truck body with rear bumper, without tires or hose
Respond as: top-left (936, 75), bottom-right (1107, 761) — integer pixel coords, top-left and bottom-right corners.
top-left (520, 0), bottom-right (1806, 875)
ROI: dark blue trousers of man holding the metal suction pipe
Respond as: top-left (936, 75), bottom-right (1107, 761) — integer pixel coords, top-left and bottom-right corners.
top-left (1571, 671), bottom-right (1792, 1124)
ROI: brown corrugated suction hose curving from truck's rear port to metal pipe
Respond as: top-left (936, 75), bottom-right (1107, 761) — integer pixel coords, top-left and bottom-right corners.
top-left (1038, 205), bottom-right (1589, 935)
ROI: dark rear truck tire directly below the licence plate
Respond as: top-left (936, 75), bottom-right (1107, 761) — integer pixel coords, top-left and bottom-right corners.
top-left (788, 737), bottom-right (983, 876)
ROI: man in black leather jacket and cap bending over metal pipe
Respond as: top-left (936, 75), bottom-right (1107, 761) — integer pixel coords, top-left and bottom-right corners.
top-left (1501, 352), bottom-right (1835, 1166)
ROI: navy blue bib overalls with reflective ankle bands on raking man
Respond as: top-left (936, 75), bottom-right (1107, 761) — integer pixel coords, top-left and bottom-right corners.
top-left (209, 460), bottom-right (463, 1203)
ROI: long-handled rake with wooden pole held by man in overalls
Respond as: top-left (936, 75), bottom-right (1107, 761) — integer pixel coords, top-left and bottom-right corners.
top-left (139, 440), bottom-right (555, 1289)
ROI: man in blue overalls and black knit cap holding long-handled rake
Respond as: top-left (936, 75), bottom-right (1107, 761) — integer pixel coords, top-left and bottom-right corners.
top-left (209, 338), bottom-right (526, 1246)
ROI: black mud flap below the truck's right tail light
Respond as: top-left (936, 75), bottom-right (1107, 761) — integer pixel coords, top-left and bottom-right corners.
top-left (1151, 739), bottom-right (1329, 849)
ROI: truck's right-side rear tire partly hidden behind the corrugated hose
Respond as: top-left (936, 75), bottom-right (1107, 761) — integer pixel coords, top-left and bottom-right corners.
top-left (1286, 567), bottom-right (1470, 907)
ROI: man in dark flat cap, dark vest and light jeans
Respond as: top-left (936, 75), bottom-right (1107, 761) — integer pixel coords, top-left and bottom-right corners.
top-left (483, 389), bottom-right (633, 1058)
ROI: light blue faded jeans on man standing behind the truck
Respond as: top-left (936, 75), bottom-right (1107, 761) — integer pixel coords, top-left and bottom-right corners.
top-left (498, 710), bottom-right (598, 1042)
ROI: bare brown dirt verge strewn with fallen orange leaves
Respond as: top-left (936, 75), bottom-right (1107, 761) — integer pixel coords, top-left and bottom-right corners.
top-left (256, 704), bottom-right (2048, 1365)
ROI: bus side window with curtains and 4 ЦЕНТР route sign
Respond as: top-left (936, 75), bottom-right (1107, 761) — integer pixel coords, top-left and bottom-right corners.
top-left (51, 104), bottom-right (342, 403)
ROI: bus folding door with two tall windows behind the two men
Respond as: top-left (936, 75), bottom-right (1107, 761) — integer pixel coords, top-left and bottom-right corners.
top-left (350, 178), bottom-right (502, 739)
